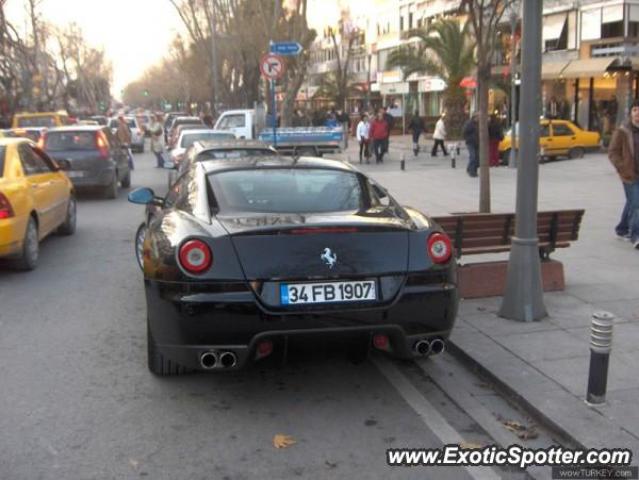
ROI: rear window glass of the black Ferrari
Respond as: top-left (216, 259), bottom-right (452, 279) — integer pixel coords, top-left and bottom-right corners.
top-left (208, 168), bottom-right (362, 213)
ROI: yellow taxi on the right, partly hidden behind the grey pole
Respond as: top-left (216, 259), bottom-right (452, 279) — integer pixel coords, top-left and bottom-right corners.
top-left (499, 119), bottom-right (601, 161)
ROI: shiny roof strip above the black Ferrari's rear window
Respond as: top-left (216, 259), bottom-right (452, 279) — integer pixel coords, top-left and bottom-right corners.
top-left (197, 156), bottom-right (358, 174)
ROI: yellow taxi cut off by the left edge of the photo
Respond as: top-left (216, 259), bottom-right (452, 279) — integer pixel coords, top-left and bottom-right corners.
top-left (0, 138), bottom-right (76, 270)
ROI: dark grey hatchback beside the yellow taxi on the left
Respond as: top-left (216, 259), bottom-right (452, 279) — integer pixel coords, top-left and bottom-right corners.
top-left (43, 125), bottom-right (131, 198)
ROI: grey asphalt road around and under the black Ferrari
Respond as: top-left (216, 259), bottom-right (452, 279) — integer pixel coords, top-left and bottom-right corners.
top-left (0, 148), bottom-right (540, 480)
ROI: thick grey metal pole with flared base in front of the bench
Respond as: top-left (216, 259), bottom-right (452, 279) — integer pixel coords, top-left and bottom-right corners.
top-left (499, 0), bottom-right (548, 322)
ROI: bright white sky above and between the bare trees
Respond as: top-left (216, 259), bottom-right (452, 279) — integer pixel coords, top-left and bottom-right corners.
top-left (5, 0), bottom-right (362, 98)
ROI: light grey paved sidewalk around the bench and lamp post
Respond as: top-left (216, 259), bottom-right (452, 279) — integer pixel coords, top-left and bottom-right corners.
top-left (332, 136), bottom-right (639, 455)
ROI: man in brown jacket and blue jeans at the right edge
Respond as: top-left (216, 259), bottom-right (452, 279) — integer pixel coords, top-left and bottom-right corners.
top-left (608, 100), bottom-right (639, 250)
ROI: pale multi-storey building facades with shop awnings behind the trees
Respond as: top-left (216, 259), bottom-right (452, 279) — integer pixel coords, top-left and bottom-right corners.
top-left (300, 0), bottom-right (639, 138)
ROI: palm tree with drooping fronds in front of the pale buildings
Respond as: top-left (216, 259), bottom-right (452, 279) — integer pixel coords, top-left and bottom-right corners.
top-left (387, 19), bottom-right (475, 137)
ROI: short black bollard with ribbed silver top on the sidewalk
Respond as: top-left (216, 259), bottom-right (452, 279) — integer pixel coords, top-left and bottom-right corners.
top-left (586, 312), bottom-right (615, 405)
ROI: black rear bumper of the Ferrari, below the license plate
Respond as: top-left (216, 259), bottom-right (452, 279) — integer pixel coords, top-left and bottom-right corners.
top-left (146, 275), bottom-right (458, 370)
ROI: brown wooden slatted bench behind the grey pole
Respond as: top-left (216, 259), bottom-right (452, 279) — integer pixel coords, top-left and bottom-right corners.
top-left (433, 210), bottom-right (585, 298)
